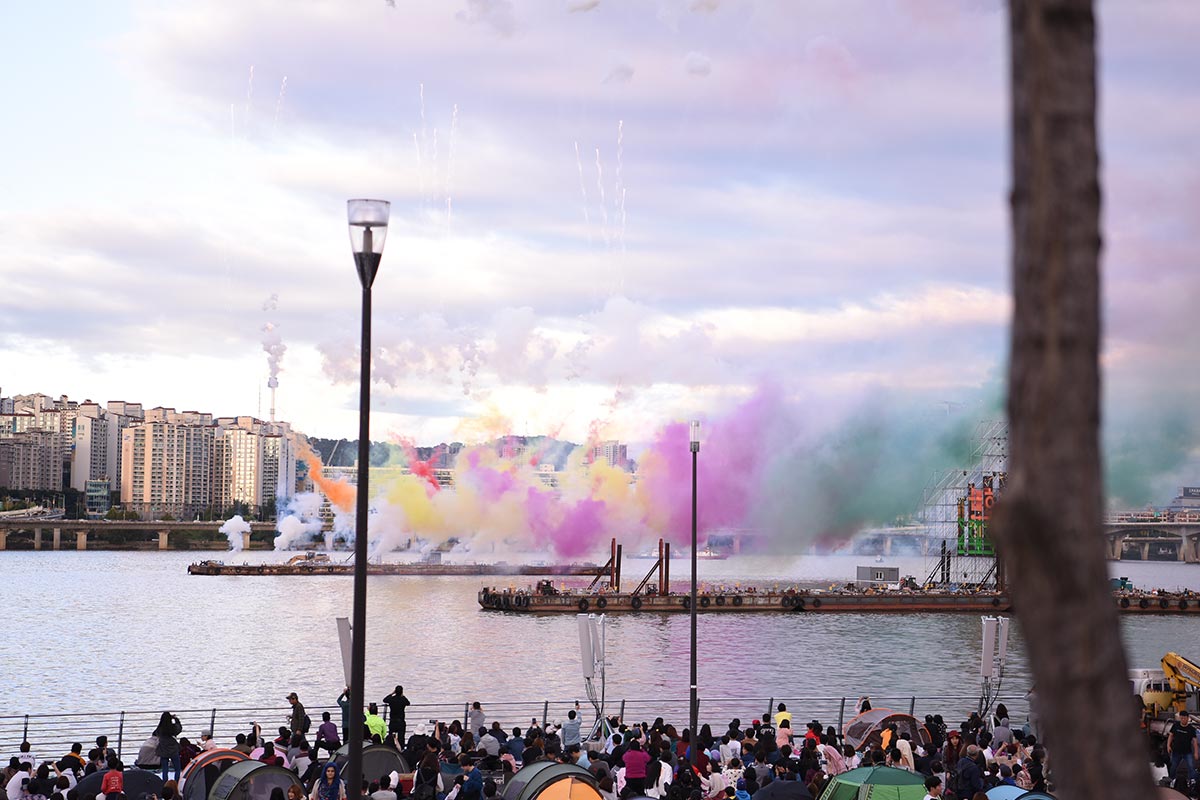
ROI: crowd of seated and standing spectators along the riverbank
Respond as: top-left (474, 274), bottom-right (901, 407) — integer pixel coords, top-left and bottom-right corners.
top-left (0, 686), bottom-right (1200, 800)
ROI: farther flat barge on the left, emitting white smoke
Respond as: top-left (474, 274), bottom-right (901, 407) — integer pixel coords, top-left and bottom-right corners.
top-left (187, 553), bottom-right (606, 577)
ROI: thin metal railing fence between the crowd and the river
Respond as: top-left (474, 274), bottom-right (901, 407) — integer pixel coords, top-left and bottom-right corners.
top-left (0, 694), bottom-right (1028, 763)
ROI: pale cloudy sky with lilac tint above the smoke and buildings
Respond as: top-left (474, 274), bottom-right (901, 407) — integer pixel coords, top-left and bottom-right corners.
top-left (0, 0), bottom-right (1200, 494)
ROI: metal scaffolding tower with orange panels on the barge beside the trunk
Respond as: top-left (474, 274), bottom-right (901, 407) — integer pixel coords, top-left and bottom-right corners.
top-left (918, 420), bottom-right (1008, 589)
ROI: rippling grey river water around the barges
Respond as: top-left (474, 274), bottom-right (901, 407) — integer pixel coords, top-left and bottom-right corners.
top-left (0, 552), bottom-right (1200, 734)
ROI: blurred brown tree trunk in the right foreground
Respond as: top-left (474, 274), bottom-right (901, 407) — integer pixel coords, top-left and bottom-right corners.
top-left (992, 0), bottom-right (1153, 800)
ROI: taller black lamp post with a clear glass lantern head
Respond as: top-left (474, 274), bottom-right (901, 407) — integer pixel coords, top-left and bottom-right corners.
top-left (346, 195), bottom-right (391, 800)
